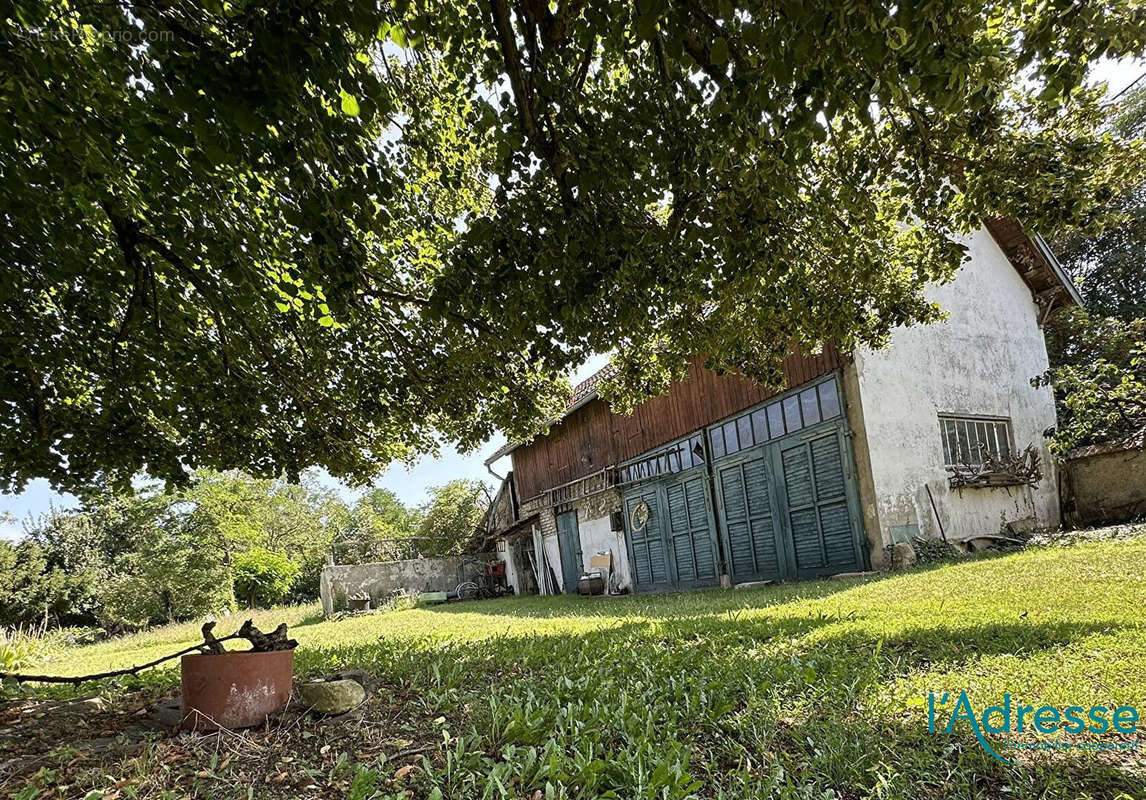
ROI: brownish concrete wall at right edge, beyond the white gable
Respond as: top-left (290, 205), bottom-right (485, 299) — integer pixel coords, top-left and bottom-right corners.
top-left (1062, 446), bottom-right (1146, 526)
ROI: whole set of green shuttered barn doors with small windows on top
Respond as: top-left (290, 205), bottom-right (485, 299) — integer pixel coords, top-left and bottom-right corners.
top-left (623, 382), bottom-right (864, 591)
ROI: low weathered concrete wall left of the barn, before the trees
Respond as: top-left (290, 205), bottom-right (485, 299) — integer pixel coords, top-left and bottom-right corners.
top-left (319, 554), bottom-right (494, 614)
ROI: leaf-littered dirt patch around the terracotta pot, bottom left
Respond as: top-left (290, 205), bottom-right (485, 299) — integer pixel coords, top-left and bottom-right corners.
top-left (0, 687), bottom-right (441, 800)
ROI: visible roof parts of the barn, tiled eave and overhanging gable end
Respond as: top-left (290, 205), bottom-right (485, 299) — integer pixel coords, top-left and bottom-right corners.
top-left (485, 218), bottom-right (1083, 466)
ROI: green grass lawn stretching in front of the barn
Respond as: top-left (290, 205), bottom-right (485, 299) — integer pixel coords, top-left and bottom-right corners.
top-left (0, 531), bottom-right (1146, 800)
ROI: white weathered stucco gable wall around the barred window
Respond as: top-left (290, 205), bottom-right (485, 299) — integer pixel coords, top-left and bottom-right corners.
top-left (849, 224), bottom-right (1059, 547)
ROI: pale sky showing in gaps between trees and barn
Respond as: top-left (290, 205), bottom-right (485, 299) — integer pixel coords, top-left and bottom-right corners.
top-left (0, 60), bottom-right (1146, 539)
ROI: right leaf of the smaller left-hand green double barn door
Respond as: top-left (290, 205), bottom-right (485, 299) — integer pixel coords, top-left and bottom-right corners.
top-left (664, 470), bottom-right (720, 589)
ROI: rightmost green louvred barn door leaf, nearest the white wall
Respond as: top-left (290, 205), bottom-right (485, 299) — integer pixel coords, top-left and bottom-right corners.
top-left (777, 428), bottom-right (863, 578)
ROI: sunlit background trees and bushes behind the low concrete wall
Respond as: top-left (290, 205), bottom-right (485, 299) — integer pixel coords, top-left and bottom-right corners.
top-left (10, 471), bottom-right (488, 628)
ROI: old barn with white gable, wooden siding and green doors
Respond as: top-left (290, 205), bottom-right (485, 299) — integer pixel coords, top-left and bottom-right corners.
top-left (486, 219), bottom-right (1080, 594)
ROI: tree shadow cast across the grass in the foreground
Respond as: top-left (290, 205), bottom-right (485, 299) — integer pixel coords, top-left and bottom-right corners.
top-left (297, 613), bottom-right (1146, 799)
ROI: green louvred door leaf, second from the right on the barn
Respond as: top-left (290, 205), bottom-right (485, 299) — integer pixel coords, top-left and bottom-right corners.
top-left (715, 448), bottom-right (784, 583)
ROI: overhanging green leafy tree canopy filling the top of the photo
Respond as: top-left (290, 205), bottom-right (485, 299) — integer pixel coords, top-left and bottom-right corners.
top-left (0, 0), bottom-right (1146, 491)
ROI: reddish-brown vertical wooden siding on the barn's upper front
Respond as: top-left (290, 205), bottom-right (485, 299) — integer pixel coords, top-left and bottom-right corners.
top-left (513, 346), bottom-right (841, 501)
